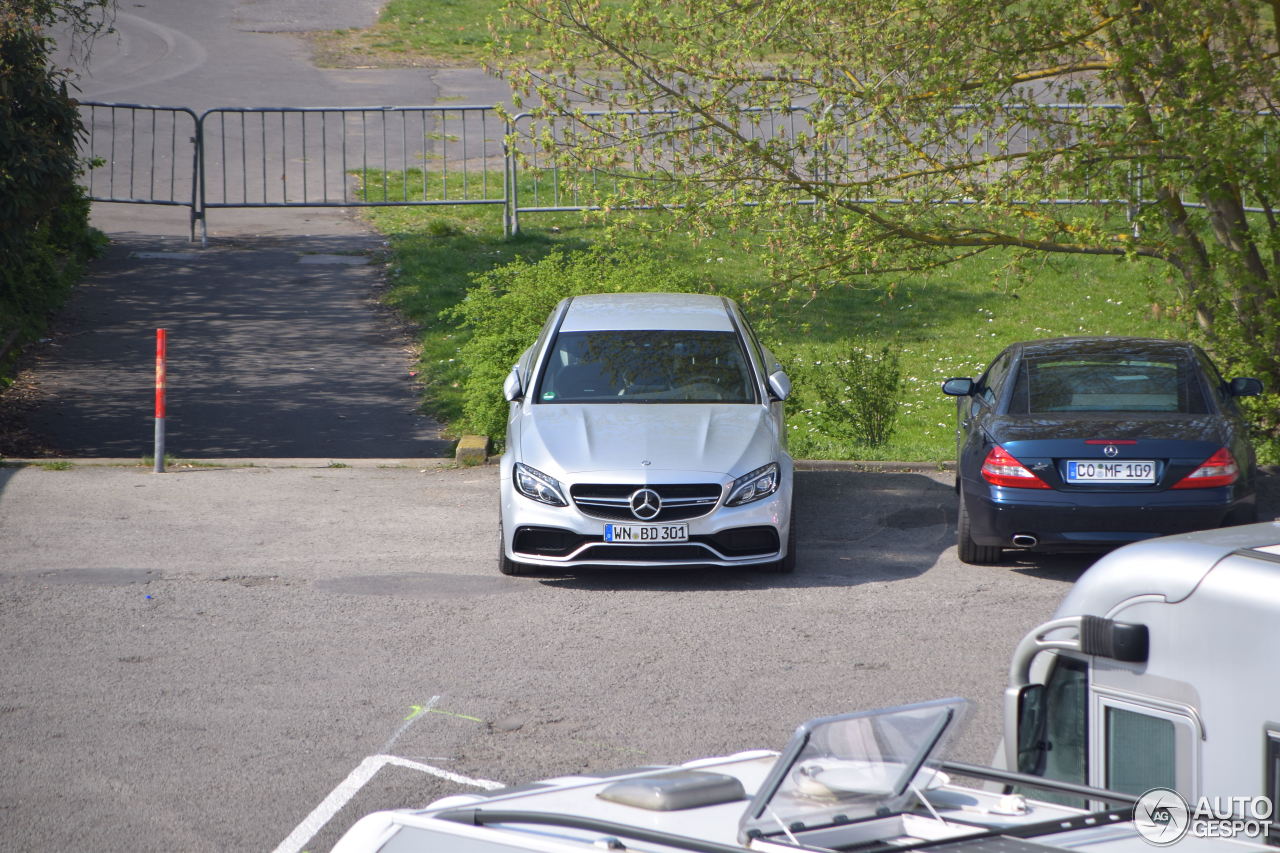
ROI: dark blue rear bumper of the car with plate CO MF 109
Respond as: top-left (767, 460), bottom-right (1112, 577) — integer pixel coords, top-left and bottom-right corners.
top-left (964, 484), bottom-right (1256, 551)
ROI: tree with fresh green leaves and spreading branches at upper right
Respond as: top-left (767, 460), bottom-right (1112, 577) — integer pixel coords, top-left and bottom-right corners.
top-left (502, 0), bottom-right (1280, 448)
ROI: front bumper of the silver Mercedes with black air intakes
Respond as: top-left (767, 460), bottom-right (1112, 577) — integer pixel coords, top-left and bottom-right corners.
top-left (500, 462), bottom-right (792, 569)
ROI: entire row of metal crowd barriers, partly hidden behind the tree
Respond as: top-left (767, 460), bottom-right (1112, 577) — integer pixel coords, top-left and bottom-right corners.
top-left (81, 101), bottom-right (1269, 240)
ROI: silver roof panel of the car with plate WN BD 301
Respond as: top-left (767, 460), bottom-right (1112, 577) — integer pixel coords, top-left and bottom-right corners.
top-left (561, 293), bottom-right (735, 332)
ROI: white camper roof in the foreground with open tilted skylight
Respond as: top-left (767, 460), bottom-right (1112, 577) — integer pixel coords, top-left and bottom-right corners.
top-left (333, 699), bottom-right (1268, 853)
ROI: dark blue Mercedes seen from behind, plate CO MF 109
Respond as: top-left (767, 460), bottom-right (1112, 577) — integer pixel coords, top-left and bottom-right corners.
top-left (942, 337), bottom-right (1262, 564)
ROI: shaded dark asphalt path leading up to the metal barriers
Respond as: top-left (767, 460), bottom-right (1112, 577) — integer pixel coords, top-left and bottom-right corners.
top-left (8, 234), bottom-right (451, 459)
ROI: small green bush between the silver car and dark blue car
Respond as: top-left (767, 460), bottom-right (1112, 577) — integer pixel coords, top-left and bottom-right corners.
top-left (783, 341), bottom-right (902, 455)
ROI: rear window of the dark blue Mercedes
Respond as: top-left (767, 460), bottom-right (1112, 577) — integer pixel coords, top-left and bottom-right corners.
top-left (1009, 355), bottom-right (1208, 415)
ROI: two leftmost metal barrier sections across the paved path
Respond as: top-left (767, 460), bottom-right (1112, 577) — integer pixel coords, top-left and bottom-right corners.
top-left (81, 101), bottom-right (509, 240)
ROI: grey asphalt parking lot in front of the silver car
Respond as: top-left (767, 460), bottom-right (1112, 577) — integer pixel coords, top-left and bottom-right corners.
top-left (0, 465), bottom-right (1126, 850)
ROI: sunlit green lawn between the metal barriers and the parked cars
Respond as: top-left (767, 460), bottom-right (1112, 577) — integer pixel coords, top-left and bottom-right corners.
top-left (355, 174), bottom-right (1184, 462)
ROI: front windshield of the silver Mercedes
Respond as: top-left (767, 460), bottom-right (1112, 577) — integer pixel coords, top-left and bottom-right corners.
top-left (534, 330), bottom-right (756, 403)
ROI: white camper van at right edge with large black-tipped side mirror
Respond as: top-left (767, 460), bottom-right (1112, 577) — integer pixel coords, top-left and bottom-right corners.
top-left (997, 514), bottom-right (1280, 814)
